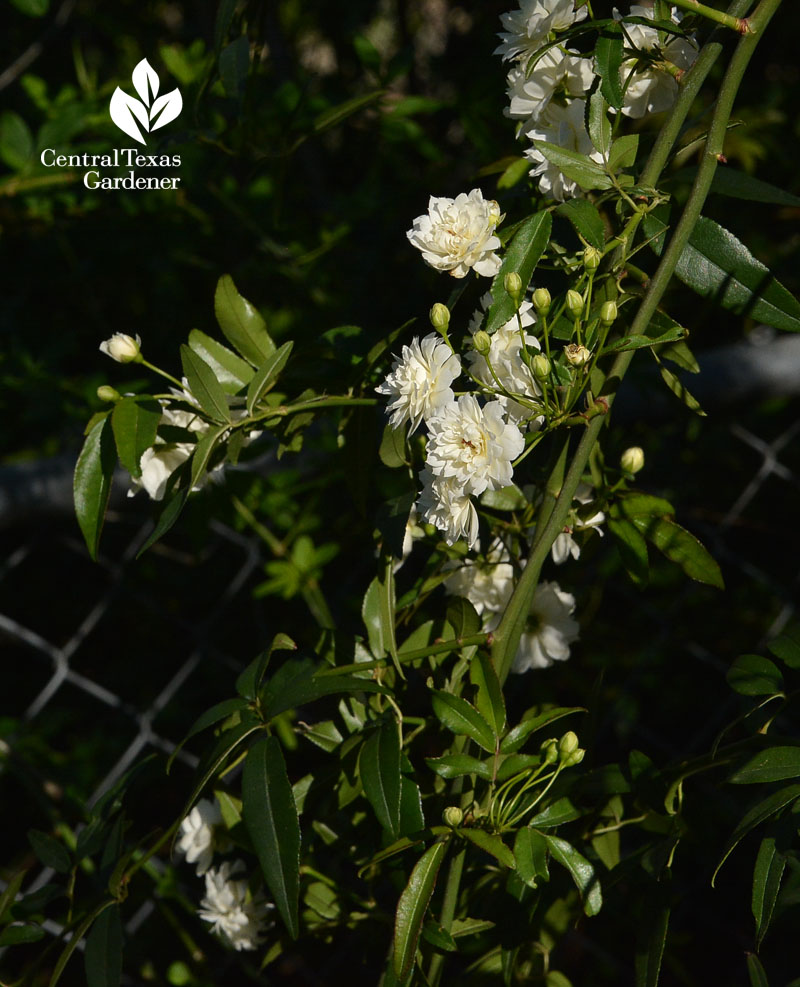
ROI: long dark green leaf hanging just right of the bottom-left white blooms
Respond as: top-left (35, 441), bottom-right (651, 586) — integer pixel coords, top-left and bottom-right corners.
top-left (242, 737), bottom-right (300, 939)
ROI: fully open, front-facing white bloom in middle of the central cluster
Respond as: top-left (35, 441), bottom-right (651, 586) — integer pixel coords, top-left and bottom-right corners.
top-left (427, 394), bottom-right (525, 496)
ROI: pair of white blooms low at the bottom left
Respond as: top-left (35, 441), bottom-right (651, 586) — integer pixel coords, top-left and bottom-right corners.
top-left (176, 799), bottom-right (273, 950)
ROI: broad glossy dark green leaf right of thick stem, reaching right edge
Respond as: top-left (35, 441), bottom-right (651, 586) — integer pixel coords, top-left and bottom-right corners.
top-left (642, 213), bottom-right (800, 332)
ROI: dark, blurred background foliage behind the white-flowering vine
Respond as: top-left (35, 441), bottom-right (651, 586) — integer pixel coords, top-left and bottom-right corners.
top-left (0, 0), bottom-right (800, 985)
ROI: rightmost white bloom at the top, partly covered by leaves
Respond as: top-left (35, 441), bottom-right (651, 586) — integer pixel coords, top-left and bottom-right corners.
top-left (620, 4), bottom-right (699, 119)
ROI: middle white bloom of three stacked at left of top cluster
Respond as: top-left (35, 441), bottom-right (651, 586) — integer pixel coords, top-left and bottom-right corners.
top-left (505, 47), bottom-right (595, 125)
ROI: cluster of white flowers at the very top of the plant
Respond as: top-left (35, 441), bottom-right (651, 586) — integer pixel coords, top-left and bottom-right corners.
top-left (495, 0), bottom-right (698, 202)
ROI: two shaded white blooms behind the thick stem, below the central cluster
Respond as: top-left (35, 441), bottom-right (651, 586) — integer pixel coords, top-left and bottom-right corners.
top-left (445, 539), bottom-right (580, 673)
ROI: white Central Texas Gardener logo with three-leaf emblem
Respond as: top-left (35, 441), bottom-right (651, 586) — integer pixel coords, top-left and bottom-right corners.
top-left (41, 58), bottom-right (183, 190)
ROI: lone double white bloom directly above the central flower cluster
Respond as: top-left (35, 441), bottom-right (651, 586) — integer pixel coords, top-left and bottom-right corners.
top-left (406, 189), bottom-right (502, 278)
